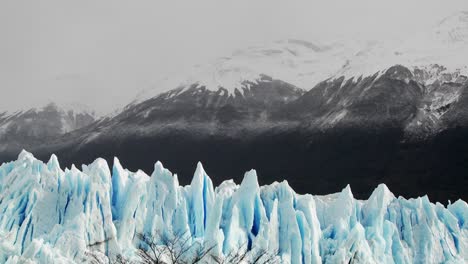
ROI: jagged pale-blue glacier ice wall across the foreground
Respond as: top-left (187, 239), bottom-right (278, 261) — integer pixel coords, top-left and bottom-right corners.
top-left (0, 151), bottom-right (468, 263)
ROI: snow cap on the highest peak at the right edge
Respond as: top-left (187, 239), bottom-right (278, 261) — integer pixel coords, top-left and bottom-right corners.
top-left (335, 12), bottom-right (468, 81)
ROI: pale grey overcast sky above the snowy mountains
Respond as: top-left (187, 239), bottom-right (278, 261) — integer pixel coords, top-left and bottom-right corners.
top-left (0, 0), bottom-right (468, 113)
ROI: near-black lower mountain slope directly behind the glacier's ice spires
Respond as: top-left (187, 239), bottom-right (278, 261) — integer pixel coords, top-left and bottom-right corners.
top-left (3, 125), bottom-right (468, 203)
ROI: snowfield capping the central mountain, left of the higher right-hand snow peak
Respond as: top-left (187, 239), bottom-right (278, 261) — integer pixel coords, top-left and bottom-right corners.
top-left (135, 39), bottom-right (355, 102)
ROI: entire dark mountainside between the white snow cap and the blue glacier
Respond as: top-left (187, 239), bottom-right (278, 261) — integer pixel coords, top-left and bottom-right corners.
top-left (0, 65), bottom-right (468, 202)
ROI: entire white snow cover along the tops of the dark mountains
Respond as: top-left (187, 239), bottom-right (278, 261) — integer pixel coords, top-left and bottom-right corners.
top-left (135, 11), bottom-right (468, 103)
